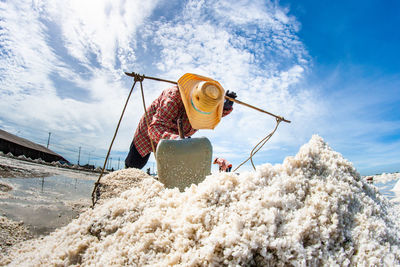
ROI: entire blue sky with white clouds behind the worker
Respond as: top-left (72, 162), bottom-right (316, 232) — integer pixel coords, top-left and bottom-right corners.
top-left (0, 0), bottom-right (400, 175)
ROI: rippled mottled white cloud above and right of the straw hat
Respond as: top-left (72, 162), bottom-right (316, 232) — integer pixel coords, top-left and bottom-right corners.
top-left (134, 1), bottom-right (319, 172)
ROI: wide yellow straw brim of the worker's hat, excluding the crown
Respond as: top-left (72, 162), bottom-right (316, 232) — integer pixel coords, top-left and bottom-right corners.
top-left (178, 73), bottom-right (225, 129)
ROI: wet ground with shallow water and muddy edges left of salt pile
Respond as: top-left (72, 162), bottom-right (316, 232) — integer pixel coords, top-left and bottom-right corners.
top-left (0, 155), bottom-right (99, 245)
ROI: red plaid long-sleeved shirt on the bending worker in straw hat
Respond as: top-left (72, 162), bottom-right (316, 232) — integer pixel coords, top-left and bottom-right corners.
top-left (133, 86), bottom-right (232, 157)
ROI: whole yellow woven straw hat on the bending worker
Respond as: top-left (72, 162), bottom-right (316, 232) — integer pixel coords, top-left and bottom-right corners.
top-left (178, 73), bottom-right (225, 129)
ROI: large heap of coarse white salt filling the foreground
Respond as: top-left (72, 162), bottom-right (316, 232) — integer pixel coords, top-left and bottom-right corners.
top-left (3, 136), bottom-right (400, 266)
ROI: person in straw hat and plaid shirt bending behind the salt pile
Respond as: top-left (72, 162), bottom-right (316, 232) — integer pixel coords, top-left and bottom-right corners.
top-left (125, 73), bottom-right (236, 169)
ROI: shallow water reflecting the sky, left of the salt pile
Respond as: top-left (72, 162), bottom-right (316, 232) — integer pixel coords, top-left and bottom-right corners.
top-left (0, 176), bottom-right (95, 235)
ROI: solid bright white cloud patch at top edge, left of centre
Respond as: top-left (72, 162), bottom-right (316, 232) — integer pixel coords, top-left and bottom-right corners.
top-left (38, 0), bottom-right (158, 71)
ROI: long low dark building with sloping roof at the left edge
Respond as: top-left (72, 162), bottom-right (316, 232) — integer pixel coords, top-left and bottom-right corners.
top-left (0, 130), bottom-right (68, 162)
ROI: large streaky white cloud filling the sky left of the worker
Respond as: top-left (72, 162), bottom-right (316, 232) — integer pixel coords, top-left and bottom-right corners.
top-left (0, 1), bottom-right (162, 163)
